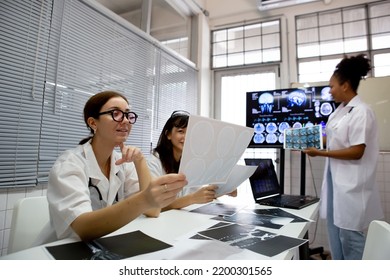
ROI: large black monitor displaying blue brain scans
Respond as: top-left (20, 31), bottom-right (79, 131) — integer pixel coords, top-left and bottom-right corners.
top-left (246, 86), bottom-right (337, 148)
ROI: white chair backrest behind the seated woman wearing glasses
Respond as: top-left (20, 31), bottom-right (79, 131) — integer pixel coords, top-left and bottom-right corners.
top-left (8, 196), bottom-right (50, 253)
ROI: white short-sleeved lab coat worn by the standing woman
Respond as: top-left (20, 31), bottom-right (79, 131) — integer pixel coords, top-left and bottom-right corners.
top-left (321, 96), bottom-right (383, 231)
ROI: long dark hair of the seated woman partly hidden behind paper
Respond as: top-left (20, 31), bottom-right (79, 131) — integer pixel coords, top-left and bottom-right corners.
top-left (153, 111), bottom-right (189, 174)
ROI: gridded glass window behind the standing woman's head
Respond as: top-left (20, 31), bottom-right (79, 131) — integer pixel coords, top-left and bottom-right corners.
top-left (296, 1), bottom-right (390, 83)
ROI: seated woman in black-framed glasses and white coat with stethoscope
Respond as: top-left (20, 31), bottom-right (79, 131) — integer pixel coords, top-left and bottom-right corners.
top-left (47, 91), bottom-right (187, 240)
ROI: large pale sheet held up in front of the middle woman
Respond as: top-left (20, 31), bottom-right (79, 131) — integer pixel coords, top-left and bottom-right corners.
top-left (179, 115), bottom-right (253, 189)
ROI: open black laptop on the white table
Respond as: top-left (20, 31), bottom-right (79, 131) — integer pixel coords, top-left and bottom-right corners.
top-left (244, 158), bottom-right (319, 209)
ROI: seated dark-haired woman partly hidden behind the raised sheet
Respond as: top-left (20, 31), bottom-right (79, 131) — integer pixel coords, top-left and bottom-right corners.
top-left (148, 111), bottom-right (237, 210)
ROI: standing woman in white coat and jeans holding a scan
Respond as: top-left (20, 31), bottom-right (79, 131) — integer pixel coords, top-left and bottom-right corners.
top-left (305, 55), bottom-right (383, 260)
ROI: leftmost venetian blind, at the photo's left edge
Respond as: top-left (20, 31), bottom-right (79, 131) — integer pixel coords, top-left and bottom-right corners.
top-left (0, 0), bottom-right (52, 187)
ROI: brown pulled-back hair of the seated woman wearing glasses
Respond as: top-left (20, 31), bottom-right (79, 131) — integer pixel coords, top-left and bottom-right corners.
top-left (79, 91), bottom-right (129, 145)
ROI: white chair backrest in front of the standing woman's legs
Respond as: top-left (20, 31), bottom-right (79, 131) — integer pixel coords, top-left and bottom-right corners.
top-left (363, 221), bottom-right (390, 260)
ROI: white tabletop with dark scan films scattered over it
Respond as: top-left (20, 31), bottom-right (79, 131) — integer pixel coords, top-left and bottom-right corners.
top-left (0, 203), bottom-right (318, 260)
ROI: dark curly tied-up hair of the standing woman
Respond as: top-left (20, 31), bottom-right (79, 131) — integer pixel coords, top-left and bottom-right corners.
top-left (333, 54), bottom-right (371, 92)
